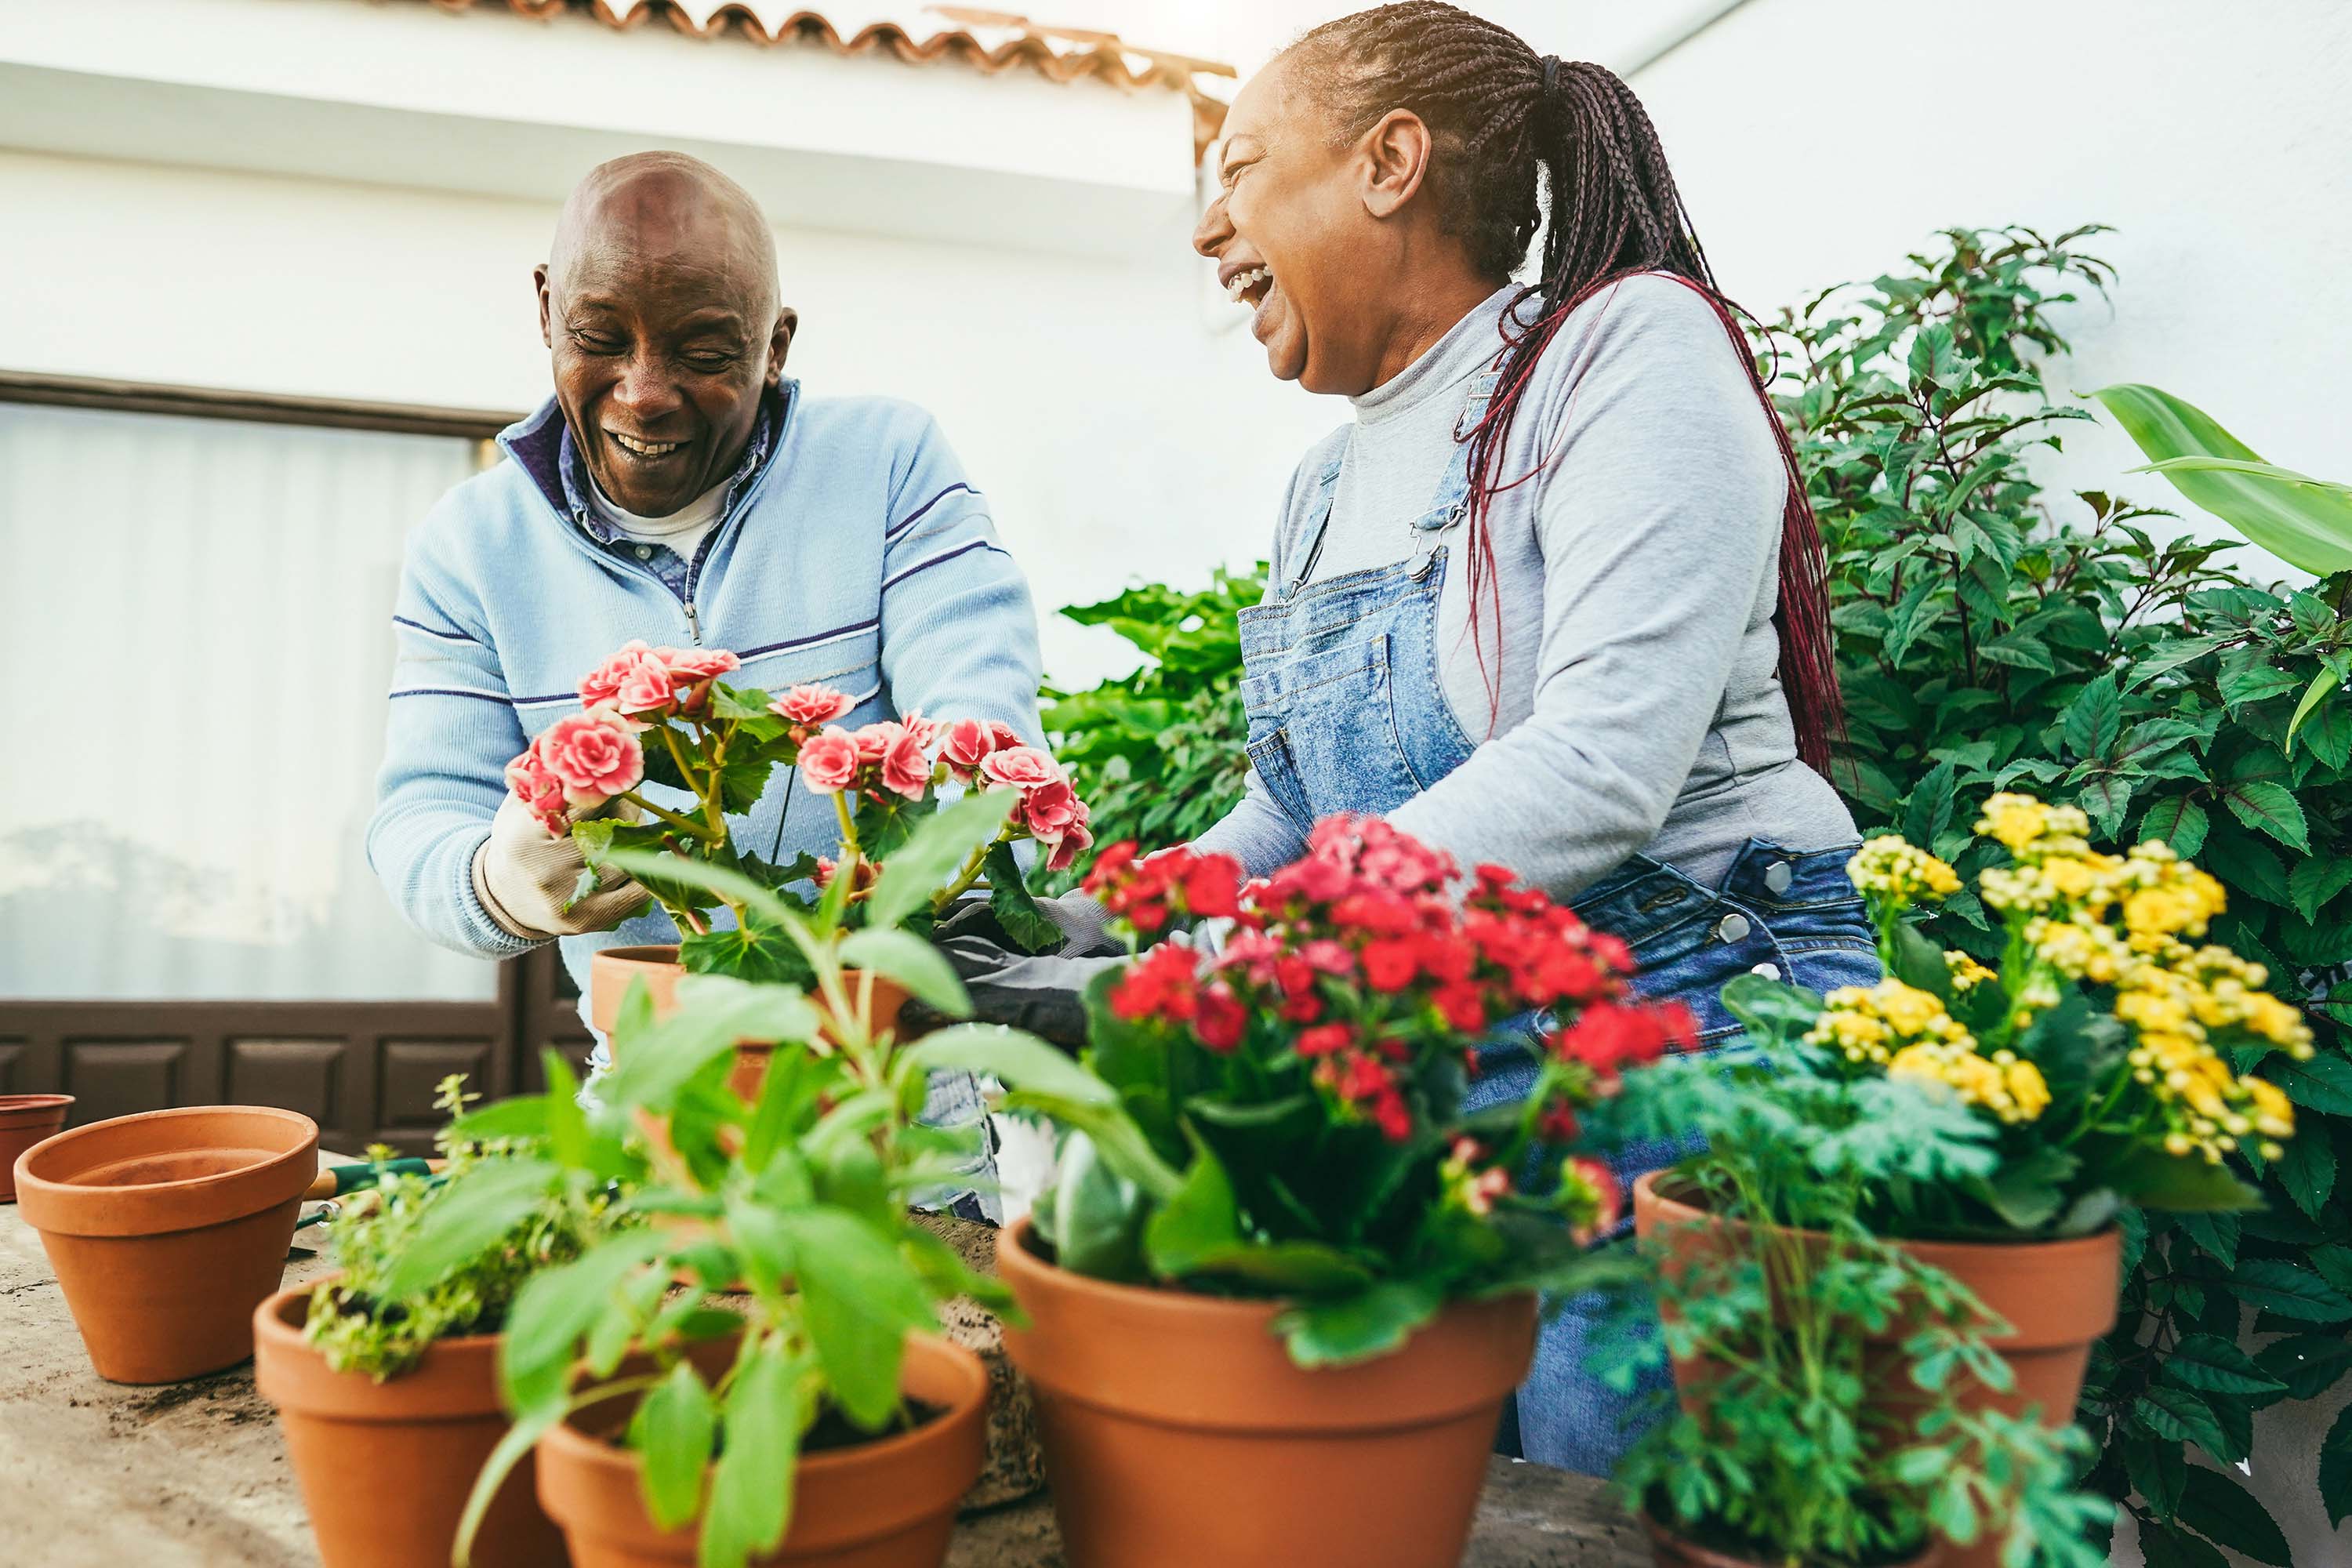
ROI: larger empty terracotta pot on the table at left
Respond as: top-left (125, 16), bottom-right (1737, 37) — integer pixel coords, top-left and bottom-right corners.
top-left (16, 1105), bottom-right (318, 1382)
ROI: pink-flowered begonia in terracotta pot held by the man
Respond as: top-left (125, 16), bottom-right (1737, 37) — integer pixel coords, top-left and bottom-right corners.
top-left (506, 642), bottom-right (1094, 1062)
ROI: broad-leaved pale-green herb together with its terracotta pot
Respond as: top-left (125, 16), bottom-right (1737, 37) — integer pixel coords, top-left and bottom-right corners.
top-left (442, 794), bottom-right (1112, 1568)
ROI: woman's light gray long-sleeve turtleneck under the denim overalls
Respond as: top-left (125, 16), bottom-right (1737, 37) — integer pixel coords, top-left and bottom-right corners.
top-left (1197, 278), bottom-right (1856, 898)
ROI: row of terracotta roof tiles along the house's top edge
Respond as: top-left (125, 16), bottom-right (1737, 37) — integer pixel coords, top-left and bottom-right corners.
top-left (414, 0), bottom-right (1235, 155)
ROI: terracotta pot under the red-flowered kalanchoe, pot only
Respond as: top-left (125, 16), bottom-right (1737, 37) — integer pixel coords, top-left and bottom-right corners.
top-left (997, 1220), bottom-right (1536, 1568)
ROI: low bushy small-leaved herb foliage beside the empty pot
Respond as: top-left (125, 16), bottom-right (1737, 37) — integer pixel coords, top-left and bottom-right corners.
top-left (303, 1076), bottom-right (616, 1382)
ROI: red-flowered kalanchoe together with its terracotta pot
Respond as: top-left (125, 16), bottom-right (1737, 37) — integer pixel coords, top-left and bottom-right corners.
top-left (997, 818), bottom-right (1689, 1568)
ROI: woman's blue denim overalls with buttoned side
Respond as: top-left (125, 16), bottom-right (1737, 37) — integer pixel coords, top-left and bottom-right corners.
top-left (1242, 374), bottom-right (1879, 1474)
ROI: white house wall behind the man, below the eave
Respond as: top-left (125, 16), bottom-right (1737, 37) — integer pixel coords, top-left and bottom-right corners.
top-left (0, 147), bottom-right (1345, 682)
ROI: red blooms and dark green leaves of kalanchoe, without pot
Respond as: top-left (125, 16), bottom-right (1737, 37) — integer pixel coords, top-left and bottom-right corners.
top-left (1037, 818), bottom-right (1689, 1366)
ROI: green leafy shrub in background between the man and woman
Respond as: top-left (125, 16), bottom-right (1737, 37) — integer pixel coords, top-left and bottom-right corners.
top-left (1037, 562), bottom-right (1265, 891)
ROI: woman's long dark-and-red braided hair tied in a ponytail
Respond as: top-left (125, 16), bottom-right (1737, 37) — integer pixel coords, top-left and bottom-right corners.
top-left (1284, 0), bottom-right (1844, 771)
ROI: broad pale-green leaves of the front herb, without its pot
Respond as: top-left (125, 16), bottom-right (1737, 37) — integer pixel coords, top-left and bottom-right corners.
top-left (402, 792), bottom-right (1110, 1568)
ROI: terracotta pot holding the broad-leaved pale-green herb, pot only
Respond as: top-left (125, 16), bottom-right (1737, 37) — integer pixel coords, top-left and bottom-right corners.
top-left (539, 1338), bottom-right (988, 1568)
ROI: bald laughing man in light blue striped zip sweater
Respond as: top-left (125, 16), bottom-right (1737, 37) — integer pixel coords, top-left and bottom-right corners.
top-left (367, 153), bottom-right (1037, 1114)
